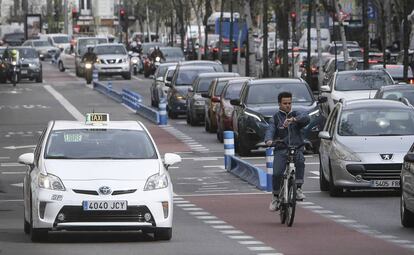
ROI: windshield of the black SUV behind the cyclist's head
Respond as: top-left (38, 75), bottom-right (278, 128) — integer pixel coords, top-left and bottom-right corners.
top-left (246, 83), bottom-right (313, 105)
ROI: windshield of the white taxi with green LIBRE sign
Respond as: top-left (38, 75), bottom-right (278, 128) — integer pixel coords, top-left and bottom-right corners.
top-left (45, 129), bottom-right (157, 159)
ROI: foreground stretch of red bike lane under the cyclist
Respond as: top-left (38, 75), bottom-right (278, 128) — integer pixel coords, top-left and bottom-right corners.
top-left (186, 194), bottom-right (413, 255)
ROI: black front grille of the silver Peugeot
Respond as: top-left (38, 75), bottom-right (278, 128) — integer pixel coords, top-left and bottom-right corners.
top-left (347, 164), bottom-right (402, 181)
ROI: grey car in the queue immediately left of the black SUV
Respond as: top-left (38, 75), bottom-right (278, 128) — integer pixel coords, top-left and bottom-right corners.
top-left (216, 77), bottom-right (253, 142)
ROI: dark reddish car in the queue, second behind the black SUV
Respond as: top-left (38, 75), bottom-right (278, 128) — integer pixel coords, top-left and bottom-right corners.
top-left (201, 75), bottom-right (240, 133)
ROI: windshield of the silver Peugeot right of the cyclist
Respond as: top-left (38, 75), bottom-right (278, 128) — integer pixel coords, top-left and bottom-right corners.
top-left (338, 107), bottom-right (414, 136)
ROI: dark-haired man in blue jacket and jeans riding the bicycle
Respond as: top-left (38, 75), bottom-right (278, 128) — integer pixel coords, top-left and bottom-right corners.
top-left (264, 92), bottom-right (310, 211)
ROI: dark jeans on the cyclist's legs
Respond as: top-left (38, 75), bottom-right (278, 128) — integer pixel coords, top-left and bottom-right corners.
top-left (272, 149), bottom-right (305, 194)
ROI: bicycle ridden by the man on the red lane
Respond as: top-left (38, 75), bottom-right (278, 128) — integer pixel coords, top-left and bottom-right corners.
top-left (272, 140), bottom-right (305, 227)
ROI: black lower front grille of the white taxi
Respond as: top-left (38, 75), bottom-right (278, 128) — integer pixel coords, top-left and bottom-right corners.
top-left (55, 206), bottom-right (155, 225)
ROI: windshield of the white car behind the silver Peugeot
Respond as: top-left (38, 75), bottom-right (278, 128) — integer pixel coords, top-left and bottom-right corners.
top-left (335, 72), bottom-right (393, 91)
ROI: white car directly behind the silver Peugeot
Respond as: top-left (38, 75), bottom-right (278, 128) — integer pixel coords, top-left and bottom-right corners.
top-left (321, 70), bottom-right (394, 115)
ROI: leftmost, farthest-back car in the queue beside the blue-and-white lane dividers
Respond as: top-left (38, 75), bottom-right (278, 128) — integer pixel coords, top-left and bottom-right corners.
top-left (150, 62), bottom-right (177, 107)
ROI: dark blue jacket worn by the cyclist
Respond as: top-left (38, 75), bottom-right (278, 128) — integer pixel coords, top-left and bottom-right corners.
top-left (264, 110), bottom-right (310, 150)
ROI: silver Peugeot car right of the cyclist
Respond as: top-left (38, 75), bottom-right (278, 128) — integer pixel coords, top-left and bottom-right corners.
top-left (319, 99), bottom-right (414, 196)
